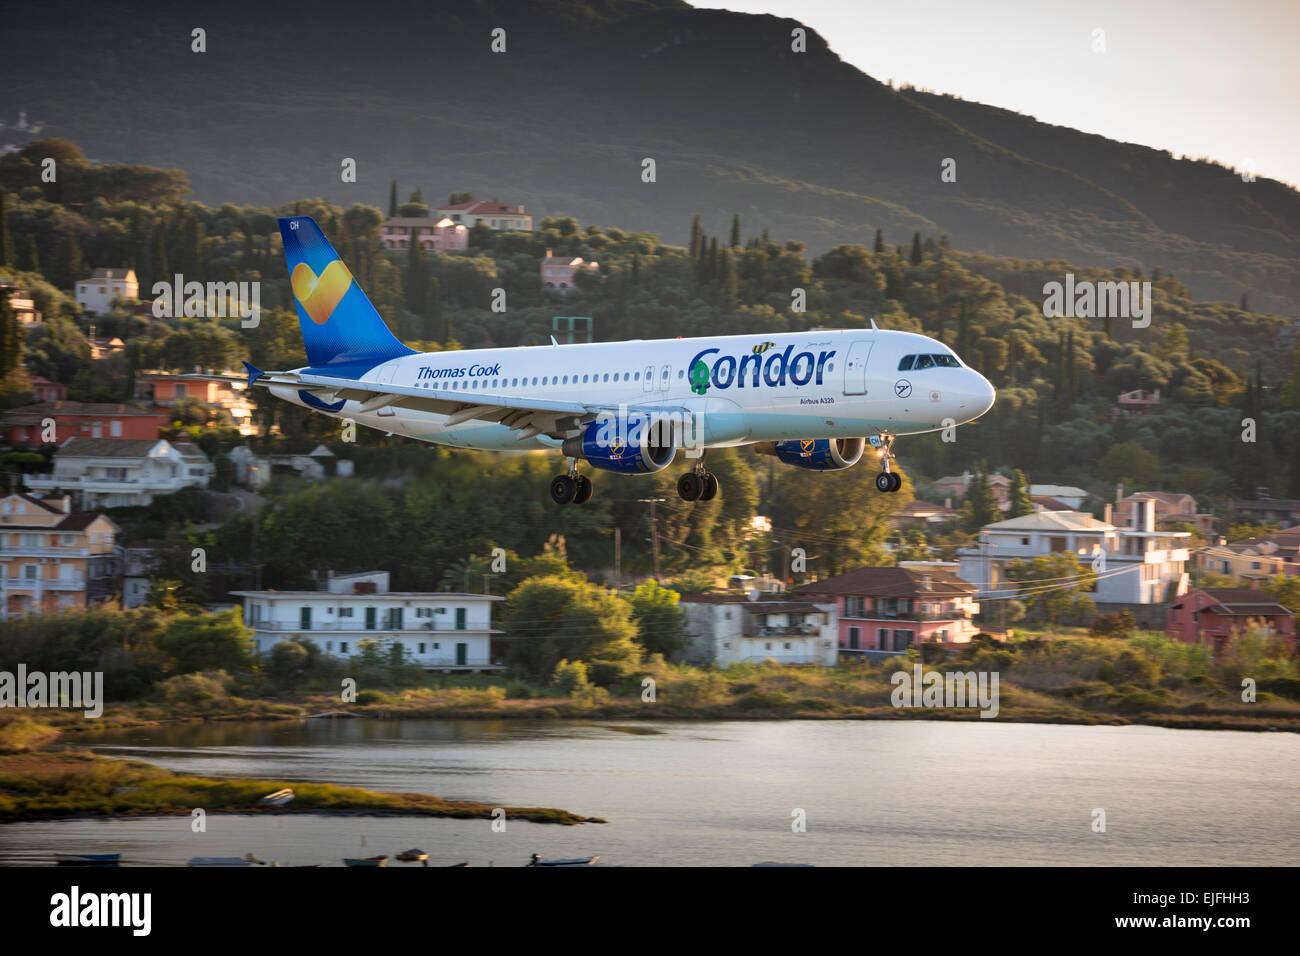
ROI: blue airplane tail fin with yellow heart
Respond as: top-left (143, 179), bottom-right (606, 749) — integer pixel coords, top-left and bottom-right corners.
top-left (280, 216), bottom-right (412, 375)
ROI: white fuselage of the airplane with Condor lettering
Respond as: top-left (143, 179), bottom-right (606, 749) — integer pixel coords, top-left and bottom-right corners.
top-left (272, 329), bottom-right (995, 450)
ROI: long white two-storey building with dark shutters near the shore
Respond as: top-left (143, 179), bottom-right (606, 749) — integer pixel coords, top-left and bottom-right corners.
top-left (230, 571), bottom-right (504, 672)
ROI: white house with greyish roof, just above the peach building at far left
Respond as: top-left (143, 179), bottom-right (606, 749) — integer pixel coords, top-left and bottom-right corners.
top-left (23, 438), bottom-right (212, 509)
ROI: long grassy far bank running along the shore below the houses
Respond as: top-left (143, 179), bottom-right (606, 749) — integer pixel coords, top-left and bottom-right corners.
top-left (17, 628), bottom-right (1300, 732)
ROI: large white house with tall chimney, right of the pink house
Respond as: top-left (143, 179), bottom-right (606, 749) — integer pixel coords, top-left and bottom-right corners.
top-left (957, 499), bottom-right (1191, 605)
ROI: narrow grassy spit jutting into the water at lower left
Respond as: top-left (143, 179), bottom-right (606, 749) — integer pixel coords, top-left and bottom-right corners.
top-left (0, 718), bottom-right (605, 825)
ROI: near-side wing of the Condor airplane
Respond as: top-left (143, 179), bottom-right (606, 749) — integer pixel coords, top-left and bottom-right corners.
top-left (244, 362), bottom-right (685, 441)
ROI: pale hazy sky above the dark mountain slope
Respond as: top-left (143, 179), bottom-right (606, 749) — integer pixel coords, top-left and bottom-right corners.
top-left (712, 0), bottom-right (1300, 185)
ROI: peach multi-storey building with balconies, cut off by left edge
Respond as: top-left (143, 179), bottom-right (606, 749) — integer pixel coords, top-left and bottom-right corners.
top-left (0, 493), bottom-right (118, 620)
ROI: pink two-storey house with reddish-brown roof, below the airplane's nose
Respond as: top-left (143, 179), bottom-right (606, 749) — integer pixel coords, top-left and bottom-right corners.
top-left (792, 567), bottom-right (987, 656)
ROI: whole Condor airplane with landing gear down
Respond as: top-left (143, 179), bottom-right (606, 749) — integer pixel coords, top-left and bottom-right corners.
top-left (244, 216), bottom-right (996, 505)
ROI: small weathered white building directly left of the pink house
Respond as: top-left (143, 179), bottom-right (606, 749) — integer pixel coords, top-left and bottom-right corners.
top-left (681, 591), bottom-right (839, 667)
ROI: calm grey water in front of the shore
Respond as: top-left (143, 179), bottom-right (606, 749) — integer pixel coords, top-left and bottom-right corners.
top-left (0, 721), bottom-right (1300, 866)
